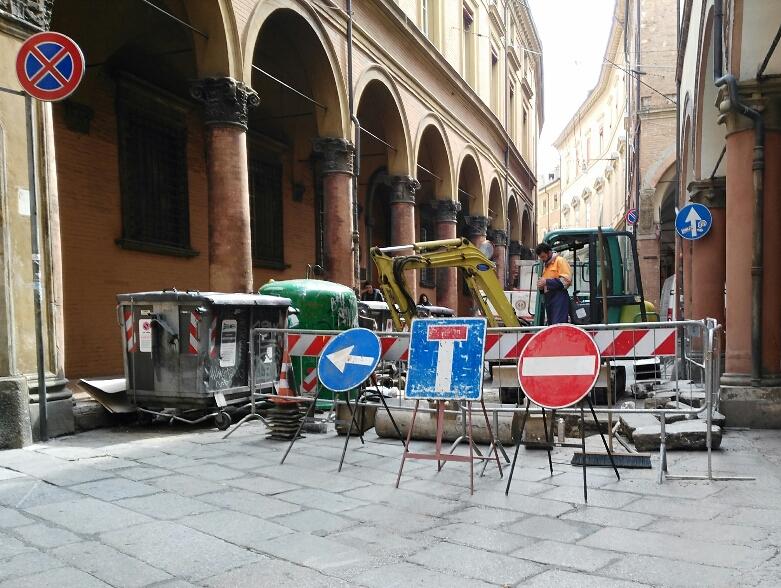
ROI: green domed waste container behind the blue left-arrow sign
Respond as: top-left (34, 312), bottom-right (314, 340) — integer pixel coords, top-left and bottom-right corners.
top-left (258, 280), bottom-right (358, 410)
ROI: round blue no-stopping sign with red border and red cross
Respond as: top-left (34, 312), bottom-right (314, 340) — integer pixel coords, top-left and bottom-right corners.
top-left (16, 31), bottom-right (84, 102)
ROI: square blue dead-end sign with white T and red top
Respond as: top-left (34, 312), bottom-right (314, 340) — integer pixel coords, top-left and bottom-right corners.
top-left (404, 317), bottom-right (486, 400)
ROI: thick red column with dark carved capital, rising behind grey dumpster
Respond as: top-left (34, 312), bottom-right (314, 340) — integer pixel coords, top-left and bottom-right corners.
top-left (190, 78), bottom-right (260, 292)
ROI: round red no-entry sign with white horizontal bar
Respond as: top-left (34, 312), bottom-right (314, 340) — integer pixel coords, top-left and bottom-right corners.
top-left (518, 324), bottom-right (600, 409)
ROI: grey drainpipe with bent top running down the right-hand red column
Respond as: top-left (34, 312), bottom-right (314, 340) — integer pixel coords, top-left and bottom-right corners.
top-left (716, 74), bottom-right (765, 386)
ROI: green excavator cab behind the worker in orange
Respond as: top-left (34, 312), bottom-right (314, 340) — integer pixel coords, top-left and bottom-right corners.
top-left (534, 228), bottom-right (659, 325)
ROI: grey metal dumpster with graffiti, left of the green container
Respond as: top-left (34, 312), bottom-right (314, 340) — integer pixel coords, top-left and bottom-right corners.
top-left (117, 290), bottom-right (290, 429)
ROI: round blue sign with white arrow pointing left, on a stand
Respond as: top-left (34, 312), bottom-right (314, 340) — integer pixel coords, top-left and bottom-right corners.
top-left (317, 329), bottom-right (382, 392)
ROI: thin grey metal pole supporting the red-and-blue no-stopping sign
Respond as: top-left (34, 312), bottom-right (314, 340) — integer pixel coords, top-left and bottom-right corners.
top-left (24, 95), bottom-right (49, 441)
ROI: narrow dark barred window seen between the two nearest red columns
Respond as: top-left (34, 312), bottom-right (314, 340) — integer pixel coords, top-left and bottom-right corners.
top-left (249, 145), bottom-right (285, 268)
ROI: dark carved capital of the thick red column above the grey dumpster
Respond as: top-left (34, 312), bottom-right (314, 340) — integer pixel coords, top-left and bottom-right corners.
top-left (190, 77), bottom-right (260, 131)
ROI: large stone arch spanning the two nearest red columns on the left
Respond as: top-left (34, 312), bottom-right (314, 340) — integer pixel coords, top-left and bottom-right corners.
top-left (242, 0), bottom-right (344, 138)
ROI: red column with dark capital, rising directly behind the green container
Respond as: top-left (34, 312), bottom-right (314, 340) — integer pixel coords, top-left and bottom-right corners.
top-left (312, 137), bottom-right (358, 287)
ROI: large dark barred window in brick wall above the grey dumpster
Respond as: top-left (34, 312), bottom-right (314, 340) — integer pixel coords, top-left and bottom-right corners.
top-left (117, 76), bottom-right (192, 256)
